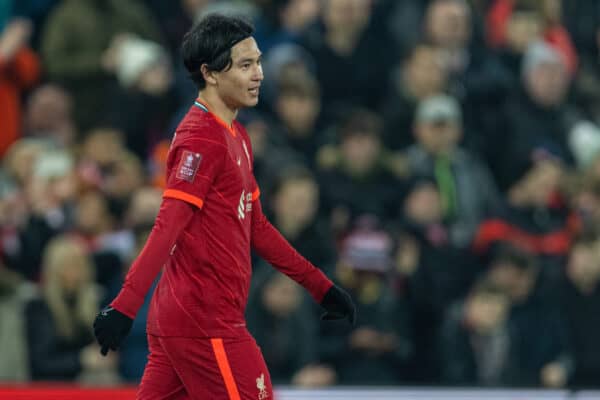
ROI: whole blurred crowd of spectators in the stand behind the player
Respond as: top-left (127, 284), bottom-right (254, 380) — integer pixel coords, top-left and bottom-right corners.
top-left (0, 0), bottom-right (600, 388)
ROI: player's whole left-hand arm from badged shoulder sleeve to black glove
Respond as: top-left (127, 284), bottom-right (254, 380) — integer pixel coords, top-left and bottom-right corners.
top-left (94, 136), bottom-right (227, 354)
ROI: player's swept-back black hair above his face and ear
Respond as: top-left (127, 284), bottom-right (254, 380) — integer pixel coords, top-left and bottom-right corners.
top-left (181, 14), bottom-right (254, 89)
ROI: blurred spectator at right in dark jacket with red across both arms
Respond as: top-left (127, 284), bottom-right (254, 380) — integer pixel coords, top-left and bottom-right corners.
top-left (473, 148), bottom-right (580, 283)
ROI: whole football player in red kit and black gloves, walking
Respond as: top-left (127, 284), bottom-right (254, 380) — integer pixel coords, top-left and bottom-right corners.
top-left (94, 14), bottom-right (355, 400)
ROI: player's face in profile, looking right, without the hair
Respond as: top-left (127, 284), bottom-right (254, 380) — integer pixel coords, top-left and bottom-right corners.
top-left (217, 37), bottom-right (263, 109)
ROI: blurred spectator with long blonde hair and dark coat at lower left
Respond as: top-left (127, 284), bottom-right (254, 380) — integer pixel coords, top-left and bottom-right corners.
top-left (25, 236), bottom-right (117, 384)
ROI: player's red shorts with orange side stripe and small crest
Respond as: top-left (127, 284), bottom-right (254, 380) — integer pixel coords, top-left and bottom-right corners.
top-left (136, 335), bottom-right (273, 400)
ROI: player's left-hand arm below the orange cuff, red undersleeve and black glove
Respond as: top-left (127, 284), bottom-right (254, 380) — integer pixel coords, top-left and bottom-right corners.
top-left (94, 197), bottom-right (194, 355)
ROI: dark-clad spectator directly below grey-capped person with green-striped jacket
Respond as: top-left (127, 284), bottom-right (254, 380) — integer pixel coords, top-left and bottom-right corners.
top-left (394, 177), bottom-right (476, 384)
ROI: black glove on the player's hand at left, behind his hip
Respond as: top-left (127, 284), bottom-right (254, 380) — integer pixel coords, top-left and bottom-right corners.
top-left (94, 307), bottom-right (133, 356)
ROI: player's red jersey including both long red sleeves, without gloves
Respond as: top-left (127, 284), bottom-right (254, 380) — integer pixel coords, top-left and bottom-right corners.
top-left (111, 102), bottom-right (333, 337)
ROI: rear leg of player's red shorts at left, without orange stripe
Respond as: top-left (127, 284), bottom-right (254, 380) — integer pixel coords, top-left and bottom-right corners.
top-left (136, 335), bottom-right (190, 400)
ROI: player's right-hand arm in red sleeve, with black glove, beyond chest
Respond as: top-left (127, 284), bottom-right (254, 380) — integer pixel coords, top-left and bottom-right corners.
top-left (251, 195), bottom-right (356, 324)
